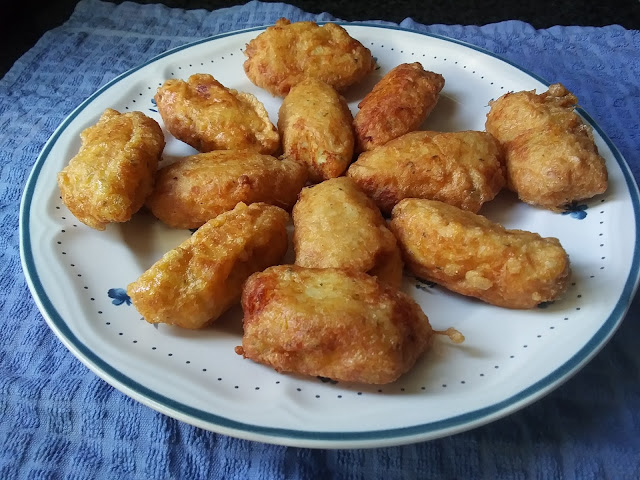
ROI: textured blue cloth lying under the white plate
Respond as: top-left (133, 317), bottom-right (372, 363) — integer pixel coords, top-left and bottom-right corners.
top-left (0, 0), bottom-right (640, 480)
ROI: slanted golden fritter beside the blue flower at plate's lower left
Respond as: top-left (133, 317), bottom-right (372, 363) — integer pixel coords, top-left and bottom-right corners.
top-left (127, 203), bottom-right (289, 329)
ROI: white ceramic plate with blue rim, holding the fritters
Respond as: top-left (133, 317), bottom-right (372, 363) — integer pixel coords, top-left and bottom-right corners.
top-left (20, 25), bottom-right (639, 448)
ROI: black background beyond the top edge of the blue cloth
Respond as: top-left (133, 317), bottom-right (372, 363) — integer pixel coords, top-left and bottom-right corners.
top-left (0, 0), bottom-right (640, 77)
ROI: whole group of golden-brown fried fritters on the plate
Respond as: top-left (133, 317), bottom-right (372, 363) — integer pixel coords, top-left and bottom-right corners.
top-left (58, 19), bottom-right (607, 384)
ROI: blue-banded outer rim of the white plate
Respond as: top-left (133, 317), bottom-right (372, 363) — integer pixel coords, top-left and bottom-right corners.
top-left (19, 21), bottom-right (640, 448)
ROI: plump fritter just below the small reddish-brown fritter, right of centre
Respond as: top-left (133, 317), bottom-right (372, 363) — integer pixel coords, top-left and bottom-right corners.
top-left (347, 131), bottom-right (505, 213)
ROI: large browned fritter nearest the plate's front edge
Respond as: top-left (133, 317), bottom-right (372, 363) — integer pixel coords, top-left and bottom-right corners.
top-left (236, 265), bottom-right (434, 384)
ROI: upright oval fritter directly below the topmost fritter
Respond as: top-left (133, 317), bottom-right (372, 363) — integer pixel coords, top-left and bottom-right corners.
top-left (278, 78), bottom-right (354, 183)
